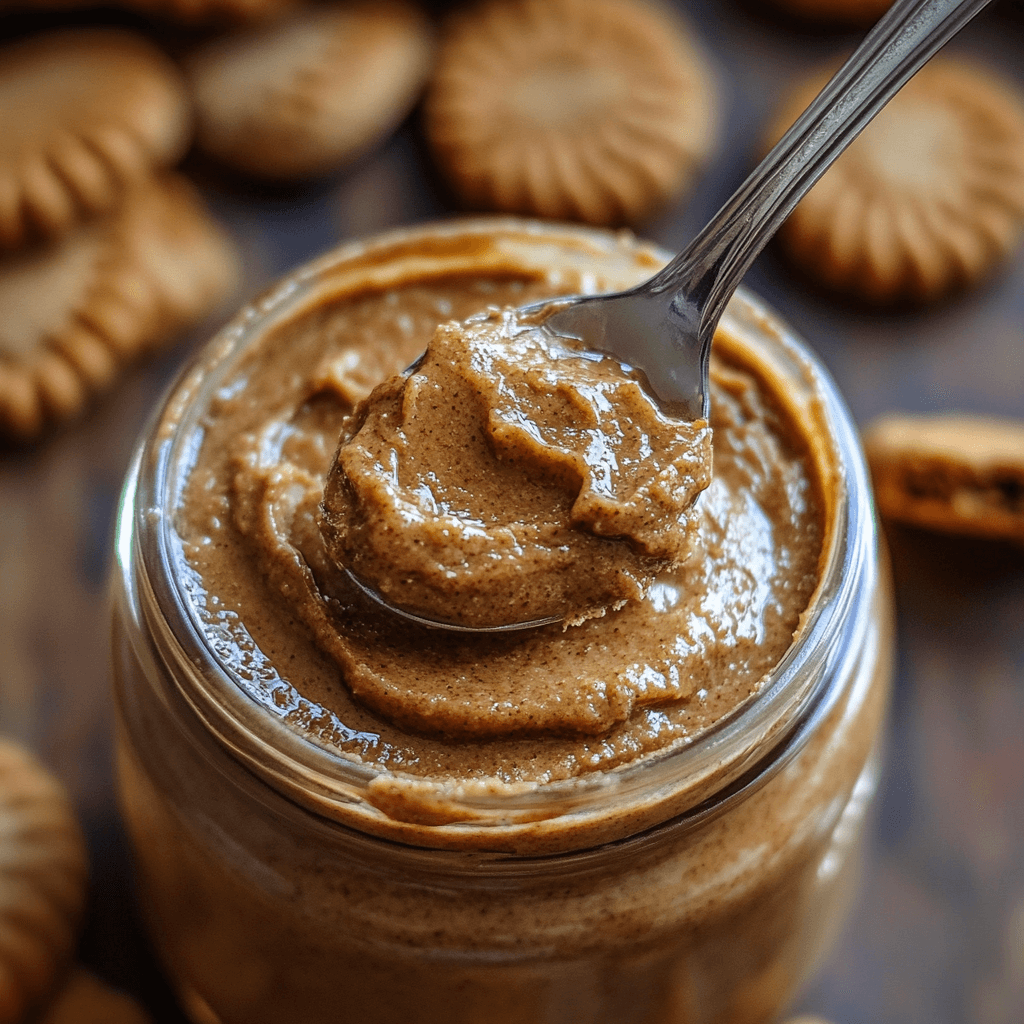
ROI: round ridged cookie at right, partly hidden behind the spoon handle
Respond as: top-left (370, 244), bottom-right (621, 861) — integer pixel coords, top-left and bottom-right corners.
top-left (769, 56), bottom-right (1024, 304)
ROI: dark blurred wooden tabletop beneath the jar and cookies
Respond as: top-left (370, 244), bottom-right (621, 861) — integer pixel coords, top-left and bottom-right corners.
top-left (0, 0), bottom-right (1024, 1024)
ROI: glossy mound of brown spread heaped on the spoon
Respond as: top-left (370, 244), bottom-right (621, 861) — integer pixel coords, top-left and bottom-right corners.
top-left (322, 301), bottom-right (711, 627)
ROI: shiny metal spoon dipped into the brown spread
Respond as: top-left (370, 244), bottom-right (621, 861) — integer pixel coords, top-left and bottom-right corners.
top-left (346, 0), bottom-right (989, 633)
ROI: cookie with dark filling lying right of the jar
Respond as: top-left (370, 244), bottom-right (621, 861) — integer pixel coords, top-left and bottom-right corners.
top-left (864, 414), bottom-right (1024, 544)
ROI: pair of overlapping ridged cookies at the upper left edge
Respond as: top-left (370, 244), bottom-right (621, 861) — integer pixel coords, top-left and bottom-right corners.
top-left (0, 29), bottom-right (237, 438)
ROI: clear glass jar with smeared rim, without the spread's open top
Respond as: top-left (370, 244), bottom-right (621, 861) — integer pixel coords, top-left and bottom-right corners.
top-left (114, 219), bottom-right (892, 1024)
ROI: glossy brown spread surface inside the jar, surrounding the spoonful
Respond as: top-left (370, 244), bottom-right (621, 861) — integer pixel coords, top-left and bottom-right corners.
top-left (176, 234), bottom-right (823, 783)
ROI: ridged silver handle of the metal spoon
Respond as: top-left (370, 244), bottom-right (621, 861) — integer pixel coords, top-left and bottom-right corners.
top-left (644, 0), bottom-right (989, 335)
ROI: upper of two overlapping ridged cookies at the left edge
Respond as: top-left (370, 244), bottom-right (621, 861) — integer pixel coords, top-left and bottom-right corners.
top-left (0, 29), bottom-right (189, 250)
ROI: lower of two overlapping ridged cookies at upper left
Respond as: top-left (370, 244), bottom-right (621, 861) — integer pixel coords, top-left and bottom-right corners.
top-left (0, 175), bottom-right (238, 438)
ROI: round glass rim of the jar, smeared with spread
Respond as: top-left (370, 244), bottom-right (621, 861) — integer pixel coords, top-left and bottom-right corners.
top-left (117, 218), bottom-right (876, 848)
